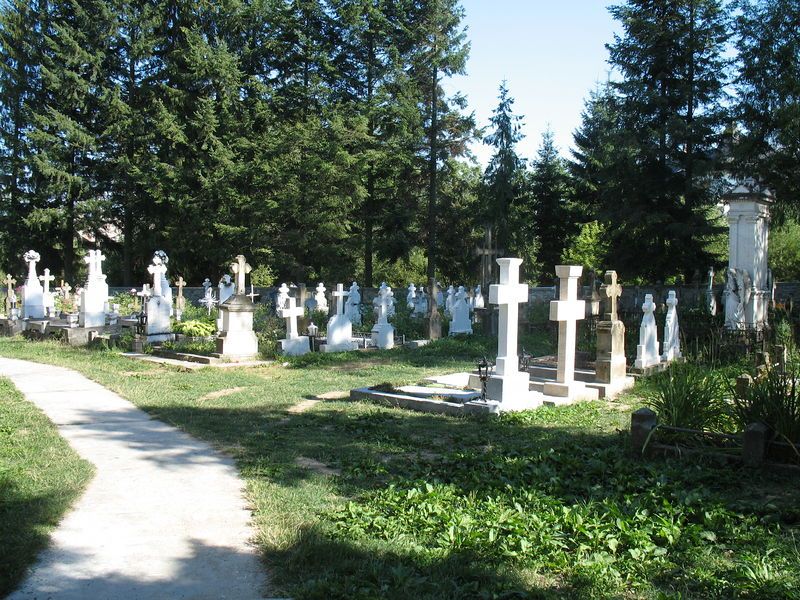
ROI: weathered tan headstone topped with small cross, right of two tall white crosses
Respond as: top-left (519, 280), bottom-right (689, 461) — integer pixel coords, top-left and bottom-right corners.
top-left (595, 271), bottom-right (627, 384)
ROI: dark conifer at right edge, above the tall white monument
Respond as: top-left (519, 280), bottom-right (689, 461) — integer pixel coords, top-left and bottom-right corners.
top-left (736, 0), bottom-right (800, 215)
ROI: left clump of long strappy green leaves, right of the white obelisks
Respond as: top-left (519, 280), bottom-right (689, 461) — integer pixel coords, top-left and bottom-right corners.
top-left (647, 363), bottom-right (730, 431)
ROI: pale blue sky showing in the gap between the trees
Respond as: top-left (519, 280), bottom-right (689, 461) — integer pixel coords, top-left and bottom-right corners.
top-left (444, 0), bottom-right (617, 165)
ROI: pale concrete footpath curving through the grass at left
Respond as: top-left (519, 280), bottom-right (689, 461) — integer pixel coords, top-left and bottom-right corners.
top-left (0, 358), bottom-right (267, 600)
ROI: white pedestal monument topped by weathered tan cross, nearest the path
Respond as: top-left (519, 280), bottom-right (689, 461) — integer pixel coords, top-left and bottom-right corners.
top-left (217, 254), bottom-right (258, 360)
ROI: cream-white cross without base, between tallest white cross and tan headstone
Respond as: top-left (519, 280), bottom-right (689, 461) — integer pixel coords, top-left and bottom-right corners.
top-left (545, 265), bottom-right (586, 386)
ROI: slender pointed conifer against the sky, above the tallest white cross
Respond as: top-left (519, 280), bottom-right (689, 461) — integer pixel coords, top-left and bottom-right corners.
top-left (483, 81), bottom-right (525, 255)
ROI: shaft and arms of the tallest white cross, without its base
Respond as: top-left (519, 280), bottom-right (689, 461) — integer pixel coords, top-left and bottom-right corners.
top-left (489, 258), bottom-right (528, 375)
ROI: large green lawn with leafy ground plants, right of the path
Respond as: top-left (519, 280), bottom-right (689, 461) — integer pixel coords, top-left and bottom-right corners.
top-left (0, 339), bottom-right (800, 599)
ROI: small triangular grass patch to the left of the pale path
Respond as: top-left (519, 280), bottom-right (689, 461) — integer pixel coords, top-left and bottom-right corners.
top-left (0, 378), bottom-right (93, 597)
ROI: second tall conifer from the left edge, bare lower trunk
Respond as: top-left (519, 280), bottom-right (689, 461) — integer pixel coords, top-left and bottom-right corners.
top-left (29, 0), bottom-right (113, 281)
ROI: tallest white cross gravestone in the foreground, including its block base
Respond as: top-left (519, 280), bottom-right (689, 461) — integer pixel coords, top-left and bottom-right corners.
top-left (486, 258), bottom-right (540, 410)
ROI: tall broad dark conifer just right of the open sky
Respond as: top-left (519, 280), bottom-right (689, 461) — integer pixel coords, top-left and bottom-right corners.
top-left (598, 0), bottom-right (728, 278)
